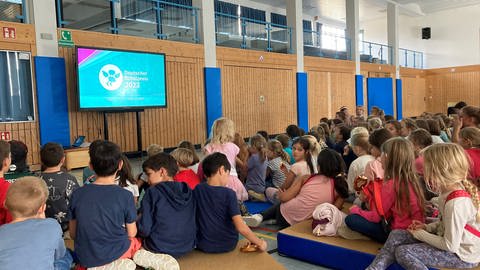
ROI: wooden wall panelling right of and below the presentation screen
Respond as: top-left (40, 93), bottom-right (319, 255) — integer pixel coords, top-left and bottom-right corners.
top-left (141, 58), bottom-right (206, 148)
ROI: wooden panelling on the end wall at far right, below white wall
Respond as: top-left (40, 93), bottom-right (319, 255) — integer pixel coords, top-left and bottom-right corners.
top-left (426, 65), bottom-right (480, 113)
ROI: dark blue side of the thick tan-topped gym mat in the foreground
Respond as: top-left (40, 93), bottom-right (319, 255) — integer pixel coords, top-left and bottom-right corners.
top-left (277, 232), bottom-right (433, 270)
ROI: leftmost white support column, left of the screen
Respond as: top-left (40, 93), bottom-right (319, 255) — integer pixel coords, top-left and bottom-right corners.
top-left (27, 0), bottom-right (58, 57)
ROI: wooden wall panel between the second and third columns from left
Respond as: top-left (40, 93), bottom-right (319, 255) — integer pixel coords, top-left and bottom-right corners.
top-left (222, 65), bottom-right (297, 137)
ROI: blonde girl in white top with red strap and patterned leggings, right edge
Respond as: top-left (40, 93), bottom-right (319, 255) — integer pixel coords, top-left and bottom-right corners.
top-left (367, 143), bottom-right (480, 269)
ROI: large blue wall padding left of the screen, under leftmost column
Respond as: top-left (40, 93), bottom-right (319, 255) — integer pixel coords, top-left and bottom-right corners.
top-left (34, 56), bottom-right (71, 147)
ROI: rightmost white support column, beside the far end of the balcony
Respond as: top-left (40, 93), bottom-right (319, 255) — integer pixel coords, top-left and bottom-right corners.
top-left (387, 2), bottom-right (400, 79)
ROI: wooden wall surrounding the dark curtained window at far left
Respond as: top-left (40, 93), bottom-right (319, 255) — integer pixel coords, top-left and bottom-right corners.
top-left (0, 21), bottom-right (40, 169)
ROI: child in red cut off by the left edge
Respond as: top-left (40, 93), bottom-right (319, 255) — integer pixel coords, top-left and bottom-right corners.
top-left (0, 140), bottom-right (12, 225)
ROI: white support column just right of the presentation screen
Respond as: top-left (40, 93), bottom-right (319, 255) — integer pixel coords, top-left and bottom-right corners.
top-left (192, 0), bottom-right (217, 67)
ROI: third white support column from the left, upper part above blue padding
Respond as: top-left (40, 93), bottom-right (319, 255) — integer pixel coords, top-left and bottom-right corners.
top-left (286, 0), bottom-right (304, 72)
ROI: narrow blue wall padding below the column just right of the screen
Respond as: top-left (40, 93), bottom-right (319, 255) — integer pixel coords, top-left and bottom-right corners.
top-left (203, 67), bottom-right (223, 138)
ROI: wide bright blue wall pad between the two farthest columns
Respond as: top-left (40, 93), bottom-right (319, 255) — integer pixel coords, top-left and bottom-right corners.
top-left (367, 78), bottom-right (394, 115)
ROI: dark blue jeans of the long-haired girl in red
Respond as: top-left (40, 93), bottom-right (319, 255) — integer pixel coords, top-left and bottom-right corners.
top-left (345, 214), bottom-right (388, 243)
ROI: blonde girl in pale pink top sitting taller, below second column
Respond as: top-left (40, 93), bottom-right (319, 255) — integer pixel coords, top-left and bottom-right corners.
top-left (199, 117), bottom-right (248, 201)
